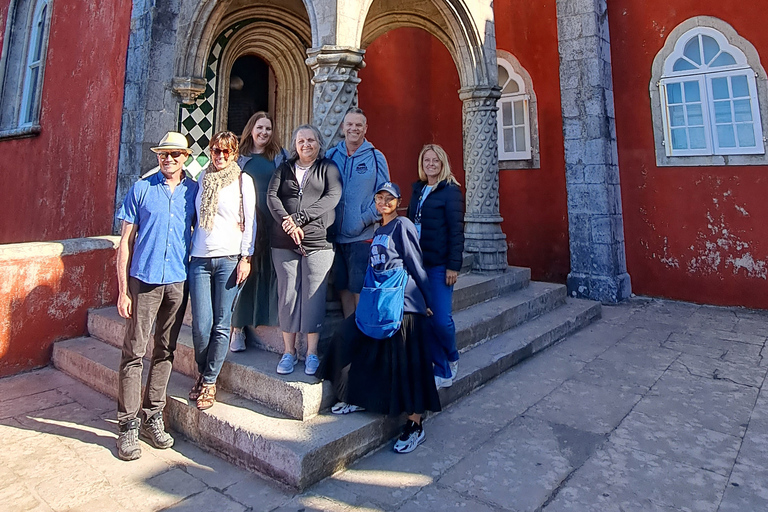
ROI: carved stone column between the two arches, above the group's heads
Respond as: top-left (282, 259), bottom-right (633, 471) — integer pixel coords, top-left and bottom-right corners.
top-left (307, 46), bottom-right (365, 148)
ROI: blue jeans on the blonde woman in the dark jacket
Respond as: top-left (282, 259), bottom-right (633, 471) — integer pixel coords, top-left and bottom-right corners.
top-left (426, 266), bottom-right (459, 378)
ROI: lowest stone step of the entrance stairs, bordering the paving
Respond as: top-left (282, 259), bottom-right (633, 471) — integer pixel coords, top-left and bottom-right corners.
top-left (53, 299), bottom-right (600, 490)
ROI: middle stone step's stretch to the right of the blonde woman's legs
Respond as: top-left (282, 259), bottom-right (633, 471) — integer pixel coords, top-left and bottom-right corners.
top-left (453, 281), bottom-right (568, 350)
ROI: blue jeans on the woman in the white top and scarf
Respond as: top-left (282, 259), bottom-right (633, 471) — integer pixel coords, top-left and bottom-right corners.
top-left (189, 256), bottom-right (240, 384)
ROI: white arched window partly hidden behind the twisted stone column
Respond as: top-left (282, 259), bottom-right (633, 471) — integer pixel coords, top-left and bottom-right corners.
top-left (497, 59), bottom-right (531, 160)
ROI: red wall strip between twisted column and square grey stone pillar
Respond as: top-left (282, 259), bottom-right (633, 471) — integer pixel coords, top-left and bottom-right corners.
top-left (494, 0), bottom-right (570, 282)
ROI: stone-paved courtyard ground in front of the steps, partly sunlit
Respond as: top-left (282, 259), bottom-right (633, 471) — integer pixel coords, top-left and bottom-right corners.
top-left (0, 299), bottom-right (768, 512)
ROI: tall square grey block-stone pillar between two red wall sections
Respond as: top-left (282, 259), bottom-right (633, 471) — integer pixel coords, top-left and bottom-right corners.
top-left (557, 0), bottom-right (632, 302)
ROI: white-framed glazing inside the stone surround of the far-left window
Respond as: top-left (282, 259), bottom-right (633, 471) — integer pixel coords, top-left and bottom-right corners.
top-left (19, 0), bottom-right (51, 128)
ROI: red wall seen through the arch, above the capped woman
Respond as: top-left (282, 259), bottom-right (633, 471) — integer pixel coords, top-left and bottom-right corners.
top-left (358, 28), bottom-right (465, 205)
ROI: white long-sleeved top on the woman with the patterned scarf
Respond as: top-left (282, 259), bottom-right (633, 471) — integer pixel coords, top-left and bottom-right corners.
top-left (191, 170), bottom-right (256, 258)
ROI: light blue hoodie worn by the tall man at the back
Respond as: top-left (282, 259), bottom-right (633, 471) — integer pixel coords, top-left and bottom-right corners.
top-left (325, 140), bottom-right (389, 244)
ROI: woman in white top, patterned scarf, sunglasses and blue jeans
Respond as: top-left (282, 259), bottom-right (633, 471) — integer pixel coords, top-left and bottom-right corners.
top-left (189, 132), bottom-right (256, 410)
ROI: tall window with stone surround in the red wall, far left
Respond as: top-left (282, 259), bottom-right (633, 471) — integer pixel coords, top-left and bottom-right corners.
top-left (0, 0), bottom-right (53, 139)
